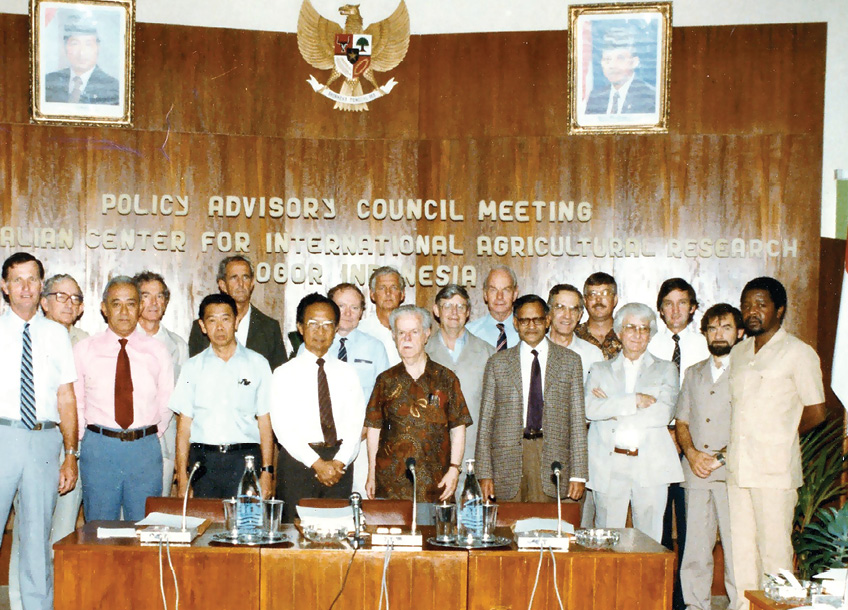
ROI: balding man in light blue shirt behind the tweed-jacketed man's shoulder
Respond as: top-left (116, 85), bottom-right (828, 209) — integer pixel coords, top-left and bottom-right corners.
top-left (468, 265), bottom-right (518, 352)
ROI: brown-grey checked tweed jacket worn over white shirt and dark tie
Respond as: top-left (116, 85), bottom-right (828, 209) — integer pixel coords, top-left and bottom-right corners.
top-left (475, 339), bottom-right (589, 498)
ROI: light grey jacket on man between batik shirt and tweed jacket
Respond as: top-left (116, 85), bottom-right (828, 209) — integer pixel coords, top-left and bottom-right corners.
top-left (424, 329), bottom-right (496, 460)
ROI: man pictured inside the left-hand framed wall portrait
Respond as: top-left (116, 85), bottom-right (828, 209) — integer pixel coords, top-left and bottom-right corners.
top-left (45, 14), bottom-right (120, 106)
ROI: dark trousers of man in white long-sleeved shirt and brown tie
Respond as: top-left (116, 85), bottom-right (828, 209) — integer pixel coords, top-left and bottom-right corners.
top-left (277, 447), bottom-right (353, 523)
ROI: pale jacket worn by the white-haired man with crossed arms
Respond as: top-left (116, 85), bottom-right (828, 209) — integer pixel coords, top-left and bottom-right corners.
top-left (586, 351), bottom-right (683, 493)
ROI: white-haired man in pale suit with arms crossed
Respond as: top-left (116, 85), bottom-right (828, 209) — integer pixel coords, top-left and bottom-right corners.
top-left (586, 303), bottom-right (683, 542)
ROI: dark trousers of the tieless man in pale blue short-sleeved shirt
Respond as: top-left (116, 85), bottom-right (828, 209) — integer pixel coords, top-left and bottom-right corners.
top-left (188, 444), bottom-right (265, 498)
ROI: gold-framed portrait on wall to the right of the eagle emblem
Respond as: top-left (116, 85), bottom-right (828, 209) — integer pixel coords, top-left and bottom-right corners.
top-left (568, 2), bottom-right (671, 133)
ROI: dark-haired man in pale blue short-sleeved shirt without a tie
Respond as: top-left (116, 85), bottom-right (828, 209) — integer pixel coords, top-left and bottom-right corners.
top-left (170, 294), bottom-right (274, 498)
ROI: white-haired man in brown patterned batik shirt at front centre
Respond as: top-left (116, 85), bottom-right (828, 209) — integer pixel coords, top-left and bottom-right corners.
top-left (365, 305), bottom-right (472, 502)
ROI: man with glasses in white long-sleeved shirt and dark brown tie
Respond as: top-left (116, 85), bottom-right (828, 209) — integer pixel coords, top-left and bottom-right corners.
top-left (271, 293), bottom-right (365, 523)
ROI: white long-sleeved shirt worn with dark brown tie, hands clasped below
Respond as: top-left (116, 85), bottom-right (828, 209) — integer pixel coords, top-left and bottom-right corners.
top-left (271, 350), bottom-right (365, 467)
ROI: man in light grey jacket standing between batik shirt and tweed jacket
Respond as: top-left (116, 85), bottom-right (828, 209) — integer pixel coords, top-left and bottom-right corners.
top-left (424, 284), bottom-right (495, 482)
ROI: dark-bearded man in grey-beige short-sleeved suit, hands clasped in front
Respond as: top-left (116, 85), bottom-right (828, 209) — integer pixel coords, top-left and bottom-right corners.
top-left (676, 303), bottom-right (744, 610)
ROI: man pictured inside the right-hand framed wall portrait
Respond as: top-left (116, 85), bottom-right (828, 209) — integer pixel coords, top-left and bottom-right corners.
top-left (586, 29), bottom-right (657, 114)
